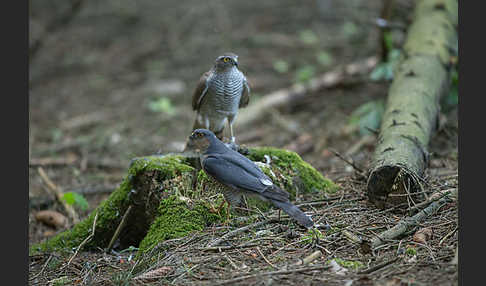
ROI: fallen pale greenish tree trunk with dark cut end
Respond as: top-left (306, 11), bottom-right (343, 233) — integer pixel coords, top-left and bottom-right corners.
top-left (367, 0), bottom-right (458, 208)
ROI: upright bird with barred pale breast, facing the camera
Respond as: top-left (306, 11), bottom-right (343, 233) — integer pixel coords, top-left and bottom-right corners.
top-left (192, 53), bottom-right (250, 144)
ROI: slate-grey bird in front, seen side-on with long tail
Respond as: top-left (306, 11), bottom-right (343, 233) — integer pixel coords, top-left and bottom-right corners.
top-left (186, 129), bottom-right (314, 228)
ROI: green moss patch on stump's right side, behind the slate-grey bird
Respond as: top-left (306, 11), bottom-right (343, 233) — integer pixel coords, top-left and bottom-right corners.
top-left (248, 147), bottom-right (338, 193)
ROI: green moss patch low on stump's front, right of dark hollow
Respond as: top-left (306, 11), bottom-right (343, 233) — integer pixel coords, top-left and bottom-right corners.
top-left (139, 196), bottom-right (221, 253)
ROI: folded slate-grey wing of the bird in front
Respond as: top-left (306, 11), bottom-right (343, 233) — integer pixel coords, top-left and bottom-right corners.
top-left (202, 154), bottom-right (289, 201)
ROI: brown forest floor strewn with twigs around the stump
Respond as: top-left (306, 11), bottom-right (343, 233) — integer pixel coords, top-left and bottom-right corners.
top-left (29, 1), bottom-right (459, 286)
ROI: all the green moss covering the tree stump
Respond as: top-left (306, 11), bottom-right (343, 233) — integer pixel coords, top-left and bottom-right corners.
top-left (30, 151), bottom-right (337, 254)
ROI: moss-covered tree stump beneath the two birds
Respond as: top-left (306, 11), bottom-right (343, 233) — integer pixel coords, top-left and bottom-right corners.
top-left (30, 148), bottom-right (337, 253)
